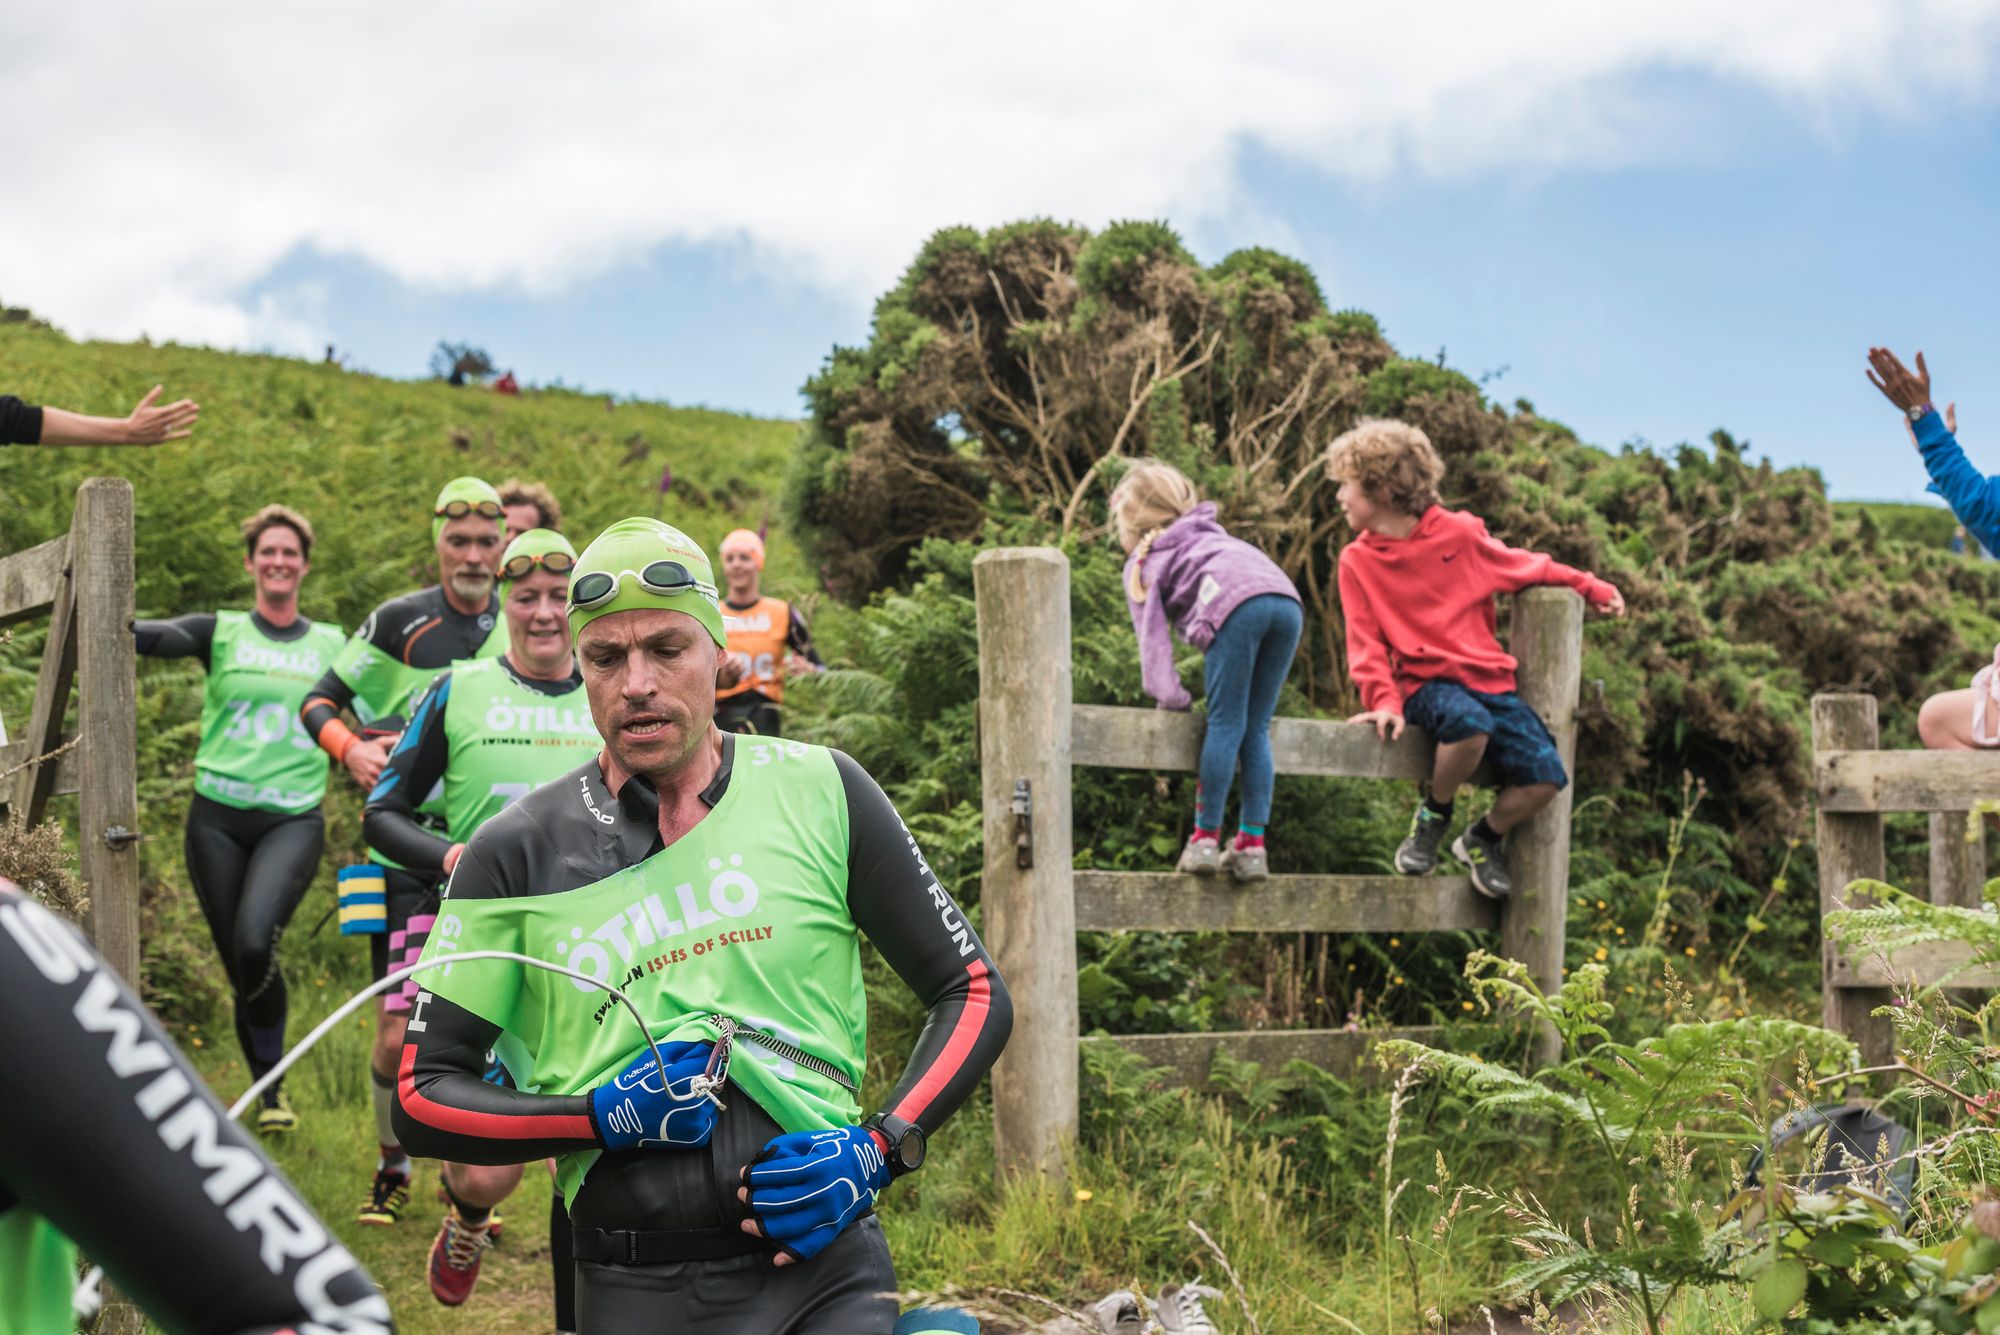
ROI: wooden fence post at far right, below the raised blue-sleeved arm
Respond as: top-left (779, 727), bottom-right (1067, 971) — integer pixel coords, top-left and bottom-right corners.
top-left (1812, 695), bottom-right (1888, 1065)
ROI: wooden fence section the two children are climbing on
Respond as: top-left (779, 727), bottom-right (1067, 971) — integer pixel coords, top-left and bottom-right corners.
top-left (972, 548), bottom-right (1584, 1173)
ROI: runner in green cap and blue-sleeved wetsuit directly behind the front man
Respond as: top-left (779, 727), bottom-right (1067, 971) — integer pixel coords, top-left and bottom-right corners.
top-left (362, 528), bottom-right (602, 1307)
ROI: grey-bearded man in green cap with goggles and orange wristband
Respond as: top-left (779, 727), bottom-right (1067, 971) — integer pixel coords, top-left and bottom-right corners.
top-left (300, 478), bottom-right (508, 1225)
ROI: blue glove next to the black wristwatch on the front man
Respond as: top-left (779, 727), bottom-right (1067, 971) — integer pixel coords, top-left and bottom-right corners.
top-left (744, 1127), bottom-right (888, 1261)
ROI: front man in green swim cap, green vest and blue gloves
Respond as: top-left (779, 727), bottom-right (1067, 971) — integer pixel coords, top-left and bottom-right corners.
top-left (396, 520), bottom-right (1012, 1335)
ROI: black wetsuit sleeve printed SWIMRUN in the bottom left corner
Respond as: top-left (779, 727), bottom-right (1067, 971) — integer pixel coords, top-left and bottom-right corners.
top-left (0, 887), bottom-right (392, 1335)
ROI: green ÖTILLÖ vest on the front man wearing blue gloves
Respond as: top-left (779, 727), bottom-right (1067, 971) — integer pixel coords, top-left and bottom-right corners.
top-left (418, 737), bottom-right (868, 1199)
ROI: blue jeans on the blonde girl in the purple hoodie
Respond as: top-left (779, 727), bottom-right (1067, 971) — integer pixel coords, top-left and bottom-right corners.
top-left (1194, 594), bottom-right (1306, 829)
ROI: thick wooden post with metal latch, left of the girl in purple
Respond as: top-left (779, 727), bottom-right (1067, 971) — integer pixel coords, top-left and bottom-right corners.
top-left (972, 548), bottom-right (1080, 1177)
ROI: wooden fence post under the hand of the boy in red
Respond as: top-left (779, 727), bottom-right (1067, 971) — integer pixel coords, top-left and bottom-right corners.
top-left (1500, 588), bottom-right (1584, 1065)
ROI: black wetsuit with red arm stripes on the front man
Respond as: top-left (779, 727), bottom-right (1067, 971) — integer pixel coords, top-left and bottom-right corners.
top-left (396, 735), bottom-right (1014, 1335)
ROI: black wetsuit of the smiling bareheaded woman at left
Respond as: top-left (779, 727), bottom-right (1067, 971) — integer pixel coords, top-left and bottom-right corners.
top-left (132, 612), bottom-right (326, 1077)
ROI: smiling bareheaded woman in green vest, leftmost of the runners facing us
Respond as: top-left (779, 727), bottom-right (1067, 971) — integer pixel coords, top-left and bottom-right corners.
top-left (132, 506), bottom-right (344, 1135)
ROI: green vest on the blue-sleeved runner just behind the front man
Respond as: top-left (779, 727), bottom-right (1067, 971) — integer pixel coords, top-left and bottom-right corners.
top-left (444, 658), bottom-right (604, 843)
